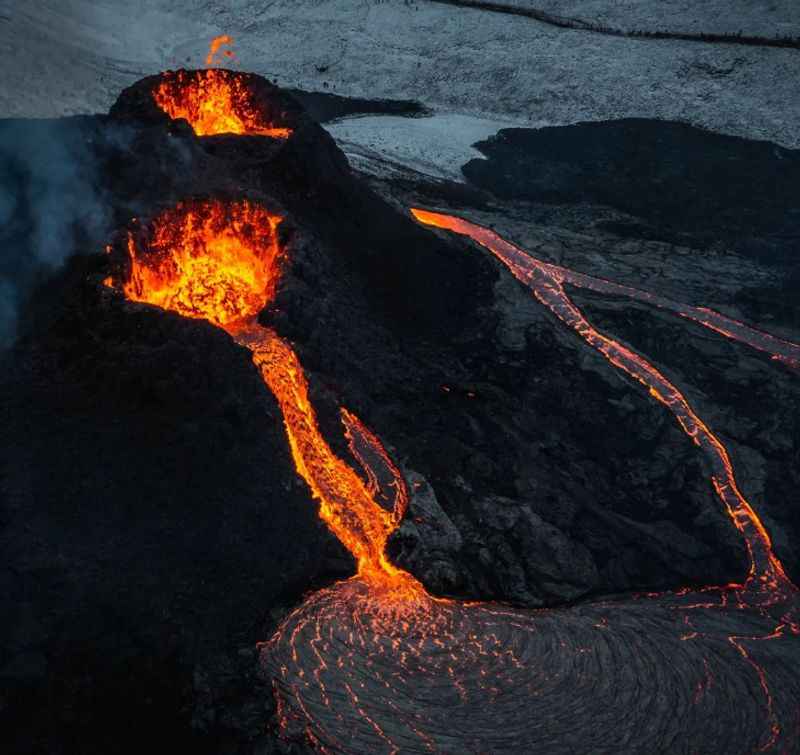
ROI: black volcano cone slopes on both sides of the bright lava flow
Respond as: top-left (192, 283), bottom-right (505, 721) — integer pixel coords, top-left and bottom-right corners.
top-left (0, 69), bottom-right (791, 753)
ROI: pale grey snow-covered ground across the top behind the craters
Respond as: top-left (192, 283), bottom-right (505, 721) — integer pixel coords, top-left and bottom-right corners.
top-left (0, 0), bottom-right (800, 177)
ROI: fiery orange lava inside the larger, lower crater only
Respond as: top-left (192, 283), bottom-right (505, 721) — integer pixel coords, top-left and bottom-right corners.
top-left (123, 200), bottom-right (281, 326)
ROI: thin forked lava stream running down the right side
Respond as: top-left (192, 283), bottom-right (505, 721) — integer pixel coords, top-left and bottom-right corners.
top-left (411, 208), bottom-right (798, 601)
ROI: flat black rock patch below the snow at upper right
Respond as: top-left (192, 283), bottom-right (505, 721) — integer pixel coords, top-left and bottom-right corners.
top-left (463, 118), bottom-right (800, 327)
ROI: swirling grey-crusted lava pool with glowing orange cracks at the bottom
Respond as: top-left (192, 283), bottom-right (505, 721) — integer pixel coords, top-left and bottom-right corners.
top-left (262, 580), bottom-right (800, 753)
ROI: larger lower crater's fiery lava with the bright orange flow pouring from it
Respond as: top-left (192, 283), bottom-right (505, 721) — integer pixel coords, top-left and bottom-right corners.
top-left (114, 200), bottom-right (424, 599)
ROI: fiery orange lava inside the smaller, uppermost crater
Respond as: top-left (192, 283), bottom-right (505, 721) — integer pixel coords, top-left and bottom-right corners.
top-left (153, 69), bottom-right (292, 139)
